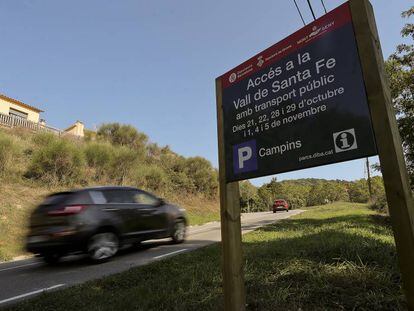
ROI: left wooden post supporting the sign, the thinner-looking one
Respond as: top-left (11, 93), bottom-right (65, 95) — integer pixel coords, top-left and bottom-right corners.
top-left (216, 79), bottom-right (246, 311)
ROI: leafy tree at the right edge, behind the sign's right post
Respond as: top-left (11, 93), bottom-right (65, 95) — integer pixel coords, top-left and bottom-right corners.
top-left (385, 6), bottom-right (414, 189)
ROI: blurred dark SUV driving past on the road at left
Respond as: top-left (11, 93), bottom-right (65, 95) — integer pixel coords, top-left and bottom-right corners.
top-left (26, 186), bottom-right (187, 263)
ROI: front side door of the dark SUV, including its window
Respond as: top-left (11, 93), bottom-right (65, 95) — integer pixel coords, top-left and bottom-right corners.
top-left (134, 190), bottom-right (168, 238)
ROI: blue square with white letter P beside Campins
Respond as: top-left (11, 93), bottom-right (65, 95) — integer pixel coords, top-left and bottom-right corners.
top-left (233, 139), bottom-right (257, 174)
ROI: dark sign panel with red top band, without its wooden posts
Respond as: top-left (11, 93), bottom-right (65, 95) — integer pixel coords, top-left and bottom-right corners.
top-left (220, 3), bottom-right (377, 181)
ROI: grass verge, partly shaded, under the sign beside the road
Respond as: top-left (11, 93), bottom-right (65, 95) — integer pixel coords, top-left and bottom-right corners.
top-left (2, 203), bottom-right (406, 311)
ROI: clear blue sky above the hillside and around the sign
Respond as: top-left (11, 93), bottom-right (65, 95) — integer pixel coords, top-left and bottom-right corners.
top-left (0, 0), bottom-right (412, 184)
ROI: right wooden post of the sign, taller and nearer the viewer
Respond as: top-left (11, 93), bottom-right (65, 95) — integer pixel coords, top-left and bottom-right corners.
top-left (350, 0), bottom-right (414, 310)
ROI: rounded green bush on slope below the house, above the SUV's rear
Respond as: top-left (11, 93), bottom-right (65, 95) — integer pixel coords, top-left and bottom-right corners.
top-left (26, 136), bottom-right (85, 184)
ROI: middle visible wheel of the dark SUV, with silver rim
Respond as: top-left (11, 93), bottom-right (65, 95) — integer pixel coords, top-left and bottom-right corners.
top-left (88, 232), bottom-right (119, 263)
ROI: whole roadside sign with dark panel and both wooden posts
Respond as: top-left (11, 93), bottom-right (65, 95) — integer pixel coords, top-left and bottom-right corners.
top-left (216, 0), bottom-right (414, 311)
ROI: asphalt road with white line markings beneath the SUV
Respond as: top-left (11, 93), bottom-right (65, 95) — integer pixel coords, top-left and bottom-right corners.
top-left (0, 210), bottom-right (302, 307)
